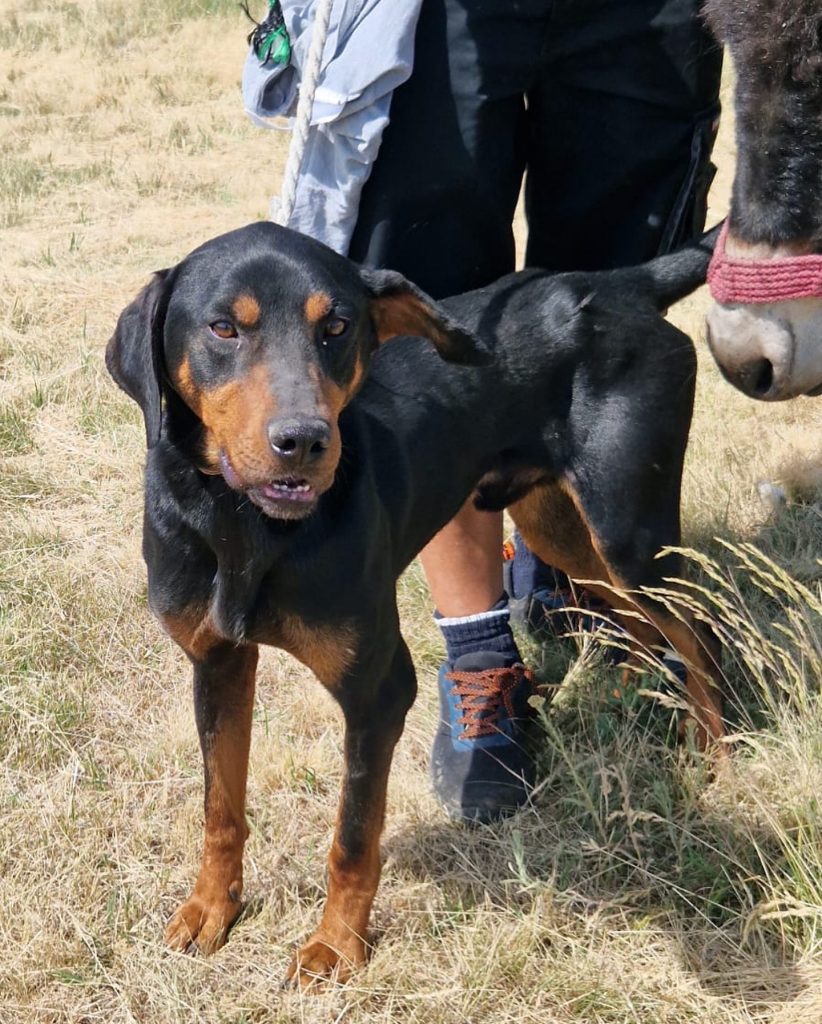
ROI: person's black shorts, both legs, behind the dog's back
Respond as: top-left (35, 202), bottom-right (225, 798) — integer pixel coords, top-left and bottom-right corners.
top-left (349, 0), bottom-right (722, 298)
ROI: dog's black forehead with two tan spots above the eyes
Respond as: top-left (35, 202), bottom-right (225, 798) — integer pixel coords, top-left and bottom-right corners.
top-left (169, 223), bottom-right (367, 329)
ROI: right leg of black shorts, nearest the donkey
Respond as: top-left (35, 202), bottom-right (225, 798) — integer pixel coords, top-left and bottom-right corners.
top-left (526, 0), bottom-right (722, 270)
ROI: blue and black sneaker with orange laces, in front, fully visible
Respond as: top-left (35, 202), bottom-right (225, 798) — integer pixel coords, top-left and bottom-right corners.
top-left (431, 651), bottom-right (533, 823)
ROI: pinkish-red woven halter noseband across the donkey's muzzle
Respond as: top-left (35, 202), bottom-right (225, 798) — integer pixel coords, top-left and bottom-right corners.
top-left (707, 220), bottom-right (822, 305)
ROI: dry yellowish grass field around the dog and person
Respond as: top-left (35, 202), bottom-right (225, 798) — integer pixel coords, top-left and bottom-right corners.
top-left (0, 0), bottom-right (822, 1024)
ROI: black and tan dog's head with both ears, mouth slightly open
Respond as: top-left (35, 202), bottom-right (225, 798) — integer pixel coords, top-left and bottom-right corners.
top-left (105, 223), bottom-right (487, 519)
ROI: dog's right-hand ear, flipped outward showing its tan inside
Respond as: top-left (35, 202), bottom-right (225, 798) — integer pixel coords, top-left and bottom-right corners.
top-left (360, 267), bottom-right (490, 366)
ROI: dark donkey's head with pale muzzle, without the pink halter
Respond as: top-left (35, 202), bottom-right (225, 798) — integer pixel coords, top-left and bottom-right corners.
top-left (704, 0), bottom-right (822, 401)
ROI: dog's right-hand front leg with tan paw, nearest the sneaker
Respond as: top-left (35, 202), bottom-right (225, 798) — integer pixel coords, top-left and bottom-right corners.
top-left (288, 640), bottom-right (417, 987)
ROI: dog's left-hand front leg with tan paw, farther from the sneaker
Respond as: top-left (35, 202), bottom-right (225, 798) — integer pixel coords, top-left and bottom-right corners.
top-left (166, 633), bottom-right (257, 953)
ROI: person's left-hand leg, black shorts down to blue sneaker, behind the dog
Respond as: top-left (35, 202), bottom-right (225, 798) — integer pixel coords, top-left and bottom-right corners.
top-left (349, 0), bottom-right (550, 820)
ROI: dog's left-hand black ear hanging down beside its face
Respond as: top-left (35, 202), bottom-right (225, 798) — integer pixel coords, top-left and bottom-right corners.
top-left (105, 270), bottom-right (173, 447)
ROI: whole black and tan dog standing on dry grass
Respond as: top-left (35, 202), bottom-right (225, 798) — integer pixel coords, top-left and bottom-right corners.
top-left (106, 223), bottom-right (723, 984)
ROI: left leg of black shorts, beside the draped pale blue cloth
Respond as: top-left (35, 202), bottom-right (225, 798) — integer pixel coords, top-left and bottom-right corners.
top-left (348, 0), bottom-right (543, 298)
